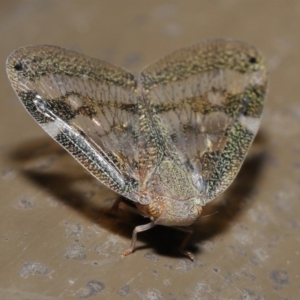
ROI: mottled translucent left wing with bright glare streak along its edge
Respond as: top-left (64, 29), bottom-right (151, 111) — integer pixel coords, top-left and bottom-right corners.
top-left (7, 46), bottom-right (138, 201)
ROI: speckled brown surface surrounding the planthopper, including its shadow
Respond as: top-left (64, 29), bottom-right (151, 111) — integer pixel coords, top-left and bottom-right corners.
top-left (0, 0), bottom-right (300, 300)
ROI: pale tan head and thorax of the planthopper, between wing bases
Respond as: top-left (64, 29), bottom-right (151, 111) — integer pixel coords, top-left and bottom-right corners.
top-left (137, 158), bottom-right (204, 226)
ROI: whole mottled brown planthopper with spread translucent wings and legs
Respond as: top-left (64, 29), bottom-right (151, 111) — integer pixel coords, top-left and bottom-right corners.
top-left (7, 39), bottom-right (267, 259)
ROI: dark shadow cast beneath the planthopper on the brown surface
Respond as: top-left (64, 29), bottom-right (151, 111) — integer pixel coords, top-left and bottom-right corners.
top-left (10, 133), bottom-right (266, 257)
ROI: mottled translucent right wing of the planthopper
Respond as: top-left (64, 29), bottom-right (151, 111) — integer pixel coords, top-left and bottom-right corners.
top-left (139, 40), bottom-right (267, 202)
